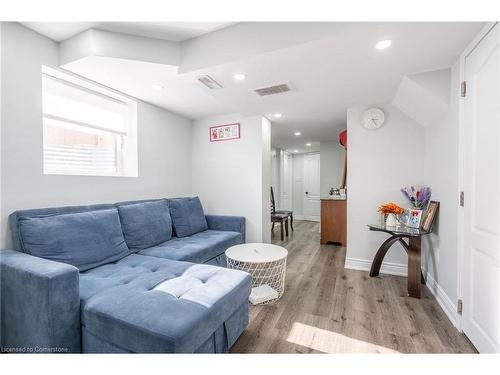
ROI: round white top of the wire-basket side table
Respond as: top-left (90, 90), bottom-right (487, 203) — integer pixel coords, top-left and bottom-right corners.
top-left (226, 243), bottom-right (288, 263)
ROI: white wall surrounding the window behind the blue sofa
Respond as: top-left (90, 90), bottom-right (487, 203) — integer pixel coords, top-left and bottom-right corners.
top-left (0, 23), bottom-right (191, 248)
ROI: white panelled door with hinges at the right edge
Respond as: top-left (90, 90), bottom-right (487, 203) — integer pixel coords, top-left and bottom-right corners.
top-left (462, 24), bottom-right (500, 353)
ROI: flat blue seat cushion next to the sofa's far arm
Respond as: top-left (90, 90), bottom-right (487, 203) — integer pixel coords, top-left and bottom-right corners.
top-left (139, 230), bottom-right (243, 263)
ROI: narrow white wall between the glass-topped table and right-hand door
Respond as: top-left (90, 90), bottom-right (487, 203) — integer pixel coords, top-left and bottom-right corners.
top-left (422, 63), bottom-right (460, 311)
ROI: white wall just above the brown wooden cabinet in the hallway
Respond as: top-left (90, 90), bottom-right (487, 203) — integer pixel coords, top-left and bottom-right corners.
top-left (319, 141), bottom-right (345, 197)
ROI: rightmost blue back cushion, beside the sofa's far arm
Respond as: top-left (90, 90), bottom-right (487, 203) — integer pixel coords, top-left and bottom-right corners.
top-left (169, 197), bottom-right (208, 237)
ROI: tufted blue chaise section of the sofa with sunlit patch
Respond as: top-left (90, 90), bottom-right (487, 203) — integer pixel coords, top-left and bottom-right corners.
top-left (80, 254), bottom-right (251, 353)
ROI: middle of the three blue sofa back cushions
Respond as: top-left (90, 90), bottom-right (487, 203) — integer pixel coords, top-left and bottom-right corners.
top-left (118, 199), bottom-right (172, 250)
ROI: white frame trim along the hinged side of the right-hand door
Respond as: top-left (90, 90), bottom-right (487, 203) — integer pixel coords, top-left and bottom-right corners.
top-left (456, 22), bottom-right (498, 332)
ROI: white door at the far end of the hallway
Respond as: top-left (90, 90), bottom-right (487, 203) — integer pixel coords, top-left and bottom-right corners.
top-left (304, 153), bottom-right (321, 221)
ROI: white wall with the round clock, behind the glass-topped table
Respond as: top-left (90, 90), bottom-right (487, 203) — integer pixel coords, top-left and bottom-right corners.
top-left (346, 104), bottom-right (425, 272)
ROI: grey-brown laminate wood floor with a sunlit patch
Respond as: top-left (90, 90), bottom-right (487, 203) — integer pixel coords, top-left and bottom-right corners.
top-left (231, 221), bottom-right (476, 353)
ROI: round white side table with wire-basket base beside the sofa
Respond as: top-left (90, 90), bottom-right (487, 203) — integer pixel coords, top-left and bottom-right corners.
top-left (226, 243), bottom-right (288, 304)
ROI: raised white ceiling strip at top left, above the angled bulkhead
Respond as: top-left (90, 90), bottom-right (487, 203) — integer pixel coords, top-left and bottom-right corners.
top-left (22, 22), bottom-right (234, 42)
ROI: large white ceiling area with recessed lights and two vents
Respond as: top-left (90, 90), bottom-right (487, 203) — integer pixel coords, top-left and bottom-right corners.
top-left (24, 22), bottom-right (483, 152)
